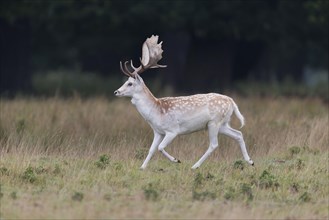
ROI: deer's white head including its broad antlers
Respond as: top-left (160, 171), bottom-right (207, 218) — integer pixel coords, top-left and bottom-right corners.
top-left (114, 35), bottom-right (166, 97)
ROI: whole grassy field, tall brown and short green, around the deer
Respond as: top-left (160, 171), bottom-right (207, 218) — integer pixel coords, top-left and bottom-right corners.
top-left (0, 97), bottom-right (329, 219)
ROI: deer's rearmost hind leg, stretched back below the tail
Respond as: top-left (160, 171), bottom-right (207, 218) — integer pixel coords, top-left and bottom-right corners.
top-left (219, 123), bottom-right (254, 165)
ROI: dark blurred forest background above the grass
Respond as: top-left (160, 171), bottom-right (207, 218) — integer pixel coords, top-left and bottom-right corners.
top-left (0, 0), bottom-right (329, 101)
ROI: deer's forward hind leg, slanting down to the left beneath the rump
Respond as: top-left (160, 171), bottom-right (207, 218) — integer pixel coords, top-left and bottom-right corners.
top-left (192, 123), bottom-right (219, 169)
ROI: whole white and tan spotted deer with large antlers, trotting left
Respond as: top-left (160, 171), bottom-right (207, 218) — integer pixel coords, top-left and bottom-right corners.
top-left (114, 35), bottom-right (254, 169)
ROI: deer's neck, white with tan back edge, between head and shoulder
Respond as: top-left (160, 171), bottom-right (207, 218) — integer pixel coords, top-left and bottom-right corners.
top-left (131, 85), bottom-right (158, 122)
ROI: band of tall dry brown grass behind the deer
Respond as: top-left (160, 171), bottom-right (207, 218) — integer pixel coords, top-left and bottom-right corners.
top-left (0, 97), bottom-right (328, 160)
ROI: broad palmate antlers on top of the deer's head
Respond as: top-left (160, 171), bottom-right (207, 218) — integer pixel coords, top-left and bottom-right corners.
top-left (120, 35), bottom-right (167, 77)
